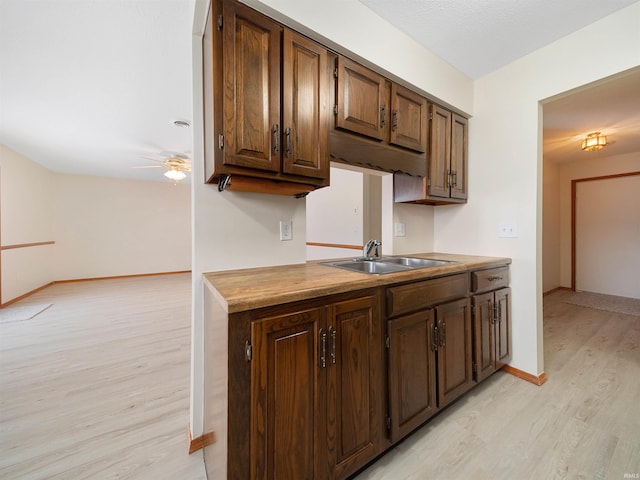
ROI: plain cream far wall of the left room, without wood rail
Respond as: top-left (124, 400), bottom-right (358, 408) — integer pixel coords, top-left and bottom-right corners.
top-left (54, 174), bottom-right (191, 280)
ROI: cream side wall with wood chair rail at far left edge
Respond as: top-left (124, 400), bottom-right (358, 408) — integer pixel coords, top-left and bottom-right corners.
top-left (0, 145), bottom-right (55, 303)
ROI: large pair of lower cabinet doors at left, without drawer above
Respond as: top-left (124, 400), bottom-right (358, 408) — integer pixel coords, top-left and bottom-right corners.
top-left (251, 294), bottom-right (384, 480)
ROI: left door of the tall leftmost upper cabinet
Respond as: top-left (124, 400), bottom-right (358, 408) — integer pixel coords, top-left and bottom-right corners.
top-left (223, 2), bottom-right (281, 172)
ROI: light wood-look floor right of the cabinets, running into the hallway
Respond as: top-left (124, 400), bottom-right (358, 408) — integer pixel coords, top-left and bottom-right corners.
top-left (357, 292), bottom-right (640, 480)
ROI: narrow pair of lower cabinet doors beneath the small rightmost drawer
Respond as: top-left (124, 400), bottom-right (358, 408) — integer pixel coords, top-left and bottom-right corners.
top-left (473, 288), bottom-right (511, 382)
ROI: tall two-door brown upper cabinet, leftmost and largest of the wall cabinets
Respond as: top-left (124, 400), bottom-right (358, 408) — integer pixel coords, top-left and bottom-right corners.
top-left (203, 0), bottom-right (333, 193)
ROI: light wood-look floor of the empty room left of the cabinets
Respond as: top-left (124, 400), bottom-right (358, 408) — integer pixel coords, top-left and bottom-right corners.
top-left (0, 274), bottom-right (206, 480)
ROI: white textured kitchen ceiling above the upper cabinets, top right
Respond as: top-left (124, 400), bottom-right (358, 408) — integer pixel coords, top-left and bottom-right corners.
top-left (359, 0), bottom-right (637, 79)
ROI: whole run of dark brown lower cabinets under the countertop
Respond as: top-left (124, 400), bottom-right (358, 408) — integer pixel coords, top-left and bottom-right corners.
top-left (228, 266), bottom-right (511, 480)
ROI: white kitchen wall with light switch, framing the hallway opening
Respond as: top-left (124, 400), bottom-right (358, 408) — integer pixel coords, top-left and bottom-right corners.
top-left (435, 3), bottom-right (640, 374)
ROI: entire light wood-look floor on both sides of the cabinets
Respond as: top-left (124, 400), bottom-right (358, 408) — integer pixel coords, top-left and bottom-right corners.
top-left (0, 274), bottom-right (640, 480)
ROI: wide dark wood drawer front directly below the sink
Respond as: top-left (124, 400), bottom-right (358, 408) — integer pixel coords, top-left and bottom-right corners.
top-left (387, 273), bottom-right (469, 317)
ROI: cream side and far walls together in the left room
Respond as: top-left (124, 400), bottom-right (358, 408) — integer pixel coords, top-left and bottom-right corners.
top-left (0, 142), bottom-right (191, 303)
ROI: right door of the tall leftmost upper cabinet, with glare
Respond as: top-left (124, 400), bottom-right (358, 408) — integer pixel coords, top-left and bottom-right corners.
top-left (282, 29), bottom-right (331, 178)
